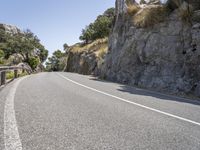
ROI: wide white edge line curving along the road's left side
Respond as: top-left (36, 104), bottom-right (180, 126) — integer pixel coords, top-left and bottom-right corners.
top-left (4, 77), bottom-right (26, 150)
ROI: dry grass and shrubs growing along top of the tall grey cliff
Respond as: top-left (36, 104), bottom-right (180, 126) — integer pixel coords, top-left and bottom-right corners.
top-left (126, 0), bottom-right (193, 28)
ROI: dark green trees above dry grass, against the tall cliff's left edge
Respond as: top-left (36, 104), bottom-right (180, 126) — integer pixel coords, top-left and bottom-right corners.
top-left (79, 8), bottom-right (114, 43)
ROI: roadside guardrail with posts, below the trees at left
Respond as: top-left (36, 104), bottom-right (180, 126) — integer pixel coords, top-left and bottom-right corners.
top-left (0, 64), bottom-right (32, 86)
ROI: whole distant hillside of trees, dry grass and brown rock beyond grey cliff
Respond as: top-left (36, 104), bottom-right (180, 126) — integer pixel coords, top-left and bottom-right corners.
top-left (46, 8), bottom-right (114, 75)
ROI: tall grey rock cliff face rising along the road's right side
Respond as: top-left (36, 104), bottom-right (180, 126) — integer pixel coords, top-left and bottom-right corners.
top-left (101, 0), bottom-right (200, 96)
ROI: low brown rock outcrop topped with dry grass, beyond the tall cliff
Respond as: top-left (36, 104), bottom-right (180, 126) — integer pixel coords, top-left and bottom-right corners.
top-left (64, 39), bottom-right (108, 75)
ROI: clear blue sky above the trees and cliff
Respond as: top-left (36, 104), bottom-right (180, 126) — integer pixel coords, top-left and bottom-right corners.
top-left (0, 0), bottom-right (115, 53)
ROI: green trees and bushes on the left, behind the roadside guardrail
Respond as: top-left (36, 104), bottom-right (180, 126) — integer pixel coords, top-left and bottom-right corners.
top-left (0, 29), bottom-right (48, 69)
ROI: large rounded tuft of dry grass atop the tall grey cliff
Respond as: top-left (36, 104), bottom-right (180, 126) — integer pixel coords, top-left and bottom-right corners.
top-left (133, 5), bottom-right (168, 28)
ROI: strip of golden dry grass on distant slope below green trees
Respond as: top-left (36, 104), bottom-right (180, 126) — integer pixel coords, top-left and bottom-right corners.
top-left (69, 38), bottom-right (108, 57)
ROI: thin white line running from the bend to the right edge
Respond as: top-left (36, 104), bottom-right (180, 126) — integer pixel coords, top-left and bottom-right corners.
top-left (57, 73), bottom-right (200, 126)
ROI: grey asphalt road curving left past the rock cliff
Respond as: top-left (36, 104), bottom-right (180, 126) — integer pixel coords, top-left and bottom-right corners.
top-left (0, 73), bottom-right (200, 150)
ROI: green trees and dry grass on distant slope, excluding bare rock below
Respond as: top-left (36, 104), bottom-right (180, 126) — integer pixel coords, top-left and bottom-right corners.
top-left (46, 8), bottom-right (114, 71)
